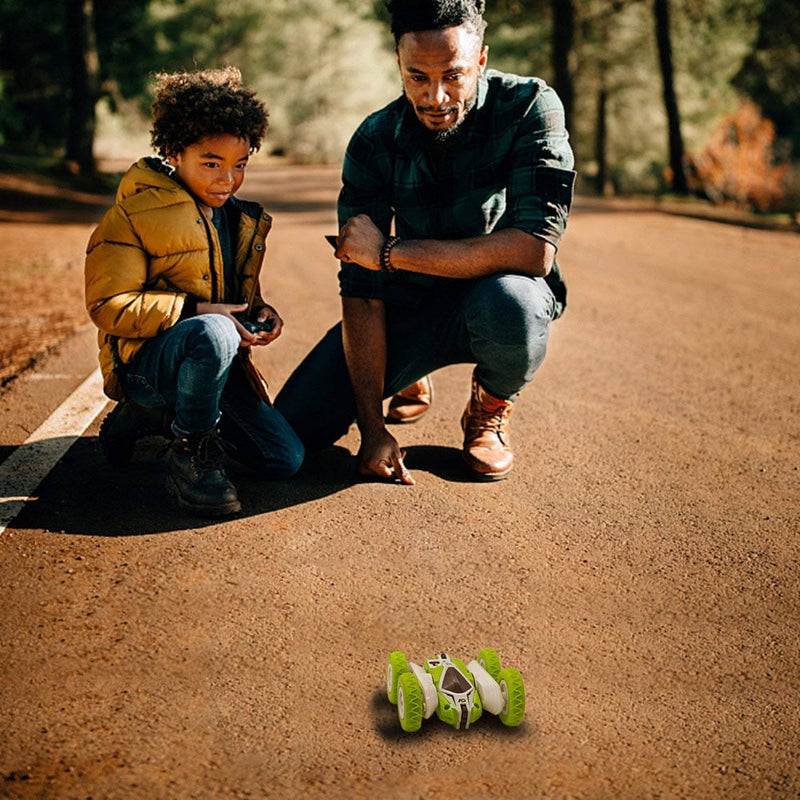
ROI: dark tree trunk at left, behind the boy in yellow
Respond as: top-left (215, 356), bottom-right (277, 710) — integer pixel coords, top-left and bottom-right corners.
top-left (66, 0), bottom-right (100, 172)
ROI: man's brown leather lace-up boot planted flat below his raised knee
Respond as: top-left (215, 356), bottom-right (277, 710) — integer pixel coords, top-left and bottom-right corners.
top-left (461, 372), bottom-right (514, 481)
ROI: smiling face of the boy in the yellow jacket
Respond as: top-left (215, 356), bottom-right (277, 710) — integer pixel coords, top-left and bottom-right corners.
top-left (167, 133), bottom-right (250, 208)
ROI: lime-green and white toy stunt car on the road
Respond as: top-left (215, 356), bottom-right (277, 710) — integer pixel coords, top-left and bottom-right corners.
top-left (386, 647), bottom-right (525, 733)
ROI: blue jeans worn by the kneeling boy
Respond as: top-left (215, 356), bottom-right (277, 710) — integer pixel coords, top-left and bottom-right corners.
top-left (122, 314), bottom-right (304, 478)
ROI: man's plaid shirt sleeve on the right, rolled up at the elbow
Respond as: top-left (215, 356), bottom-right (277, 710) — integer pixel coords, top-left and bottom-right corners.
top-left (503, 87), bottom-right (575, 247)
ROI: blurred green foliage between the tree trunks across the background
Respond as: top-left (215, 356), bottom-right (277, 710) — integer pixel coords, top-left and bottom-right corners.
top-left (0, 0), bottom-right (800, 191)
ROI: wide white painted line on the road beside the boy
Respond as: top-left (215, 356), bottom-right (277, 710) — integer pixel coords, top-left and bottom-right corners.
top-left (0, 369), bottom-right (108, 535)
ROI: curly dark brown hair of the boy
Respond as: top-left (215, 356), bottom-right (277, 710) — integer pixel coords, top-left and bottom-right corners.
top-left (150, 67), bottom-right (269, 158)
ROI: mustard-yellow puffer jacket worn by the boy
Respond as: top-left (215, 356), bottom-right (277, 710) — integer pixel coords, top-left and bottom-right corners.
top-left (85, 158), bottom-right (272, 401)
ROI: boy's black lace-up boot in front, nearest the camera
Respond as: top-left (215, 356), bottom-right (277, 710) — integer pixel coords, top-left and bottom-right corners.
top-left (167, 428), bottom-right (242, 517)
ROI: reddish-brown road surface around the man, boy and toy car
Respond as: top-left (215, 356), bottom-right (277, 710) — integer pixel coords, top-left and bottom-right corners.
top-left (0, 168), bottom-right (800, 800)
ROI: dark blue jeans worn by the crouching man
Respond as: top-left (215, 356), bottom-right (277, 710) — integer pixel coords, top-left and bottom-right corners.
top-left (275, 274), bottom-right (555, 448)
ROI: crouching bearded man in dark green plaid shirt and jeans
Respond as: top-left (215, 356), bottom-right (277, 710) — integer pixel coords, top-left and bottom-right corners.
top-left (276, 0), bottom-right (575, 484)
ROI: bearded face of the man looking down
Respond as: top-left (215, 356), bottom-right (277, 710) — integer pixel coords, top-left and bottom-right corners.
top-left (397, 25), bottom-right (489, 139)
